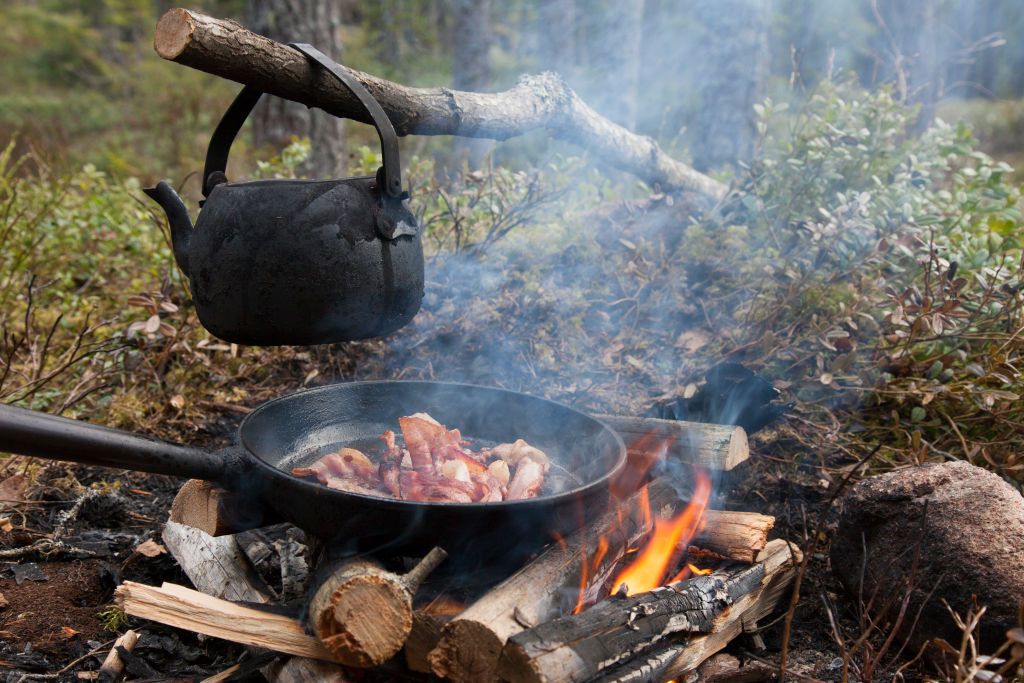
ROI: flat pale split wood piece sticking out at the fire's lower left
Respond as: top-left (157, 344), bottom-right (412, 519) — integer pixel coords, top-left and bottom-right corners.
top-left (114, 581), bottom-right (335, 661)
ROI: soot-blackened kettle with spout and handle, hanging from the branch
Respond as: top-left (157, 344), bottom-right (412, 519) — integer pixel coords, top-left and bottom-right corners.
top-left (143, 44), bottom-right (423, 346)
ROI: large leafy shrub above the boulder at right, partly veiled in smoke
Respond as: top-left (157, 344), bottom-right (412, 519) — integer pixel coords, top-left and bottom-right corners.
top-left (687, 80), bottom-right (1024, 480)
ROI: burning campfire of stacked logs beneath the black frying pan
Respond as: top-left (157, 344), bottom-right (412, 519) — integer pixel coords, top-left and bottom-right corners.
top-left (117, 416), bottom-right (799, 681)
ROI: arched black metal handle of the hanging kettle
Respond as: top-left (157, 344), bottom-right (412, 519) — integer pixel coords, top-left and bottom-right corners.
top-left (203, 43), bottom-right (402, 199)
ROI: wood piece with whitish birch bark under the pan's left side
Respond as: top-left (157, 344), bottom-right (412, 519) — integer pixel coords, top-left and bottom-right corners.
top-left (162, 521), bottom-right (272, 603)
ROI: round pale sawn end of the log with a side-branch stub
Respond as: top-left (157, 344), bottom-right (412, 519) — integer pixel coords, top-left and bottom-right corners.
top-left (315, 575), bottom-right (413, 668)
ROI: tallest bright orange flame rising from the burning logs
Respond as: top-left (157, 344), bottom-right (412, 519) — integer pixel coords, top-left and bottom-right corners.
top-left (611, 470), bottom-right (711, 595)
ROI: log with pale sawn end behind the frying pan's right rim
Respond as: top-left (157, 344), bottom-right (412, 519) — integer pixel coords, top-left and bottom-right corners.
top-left (594, 415), bottom-right (751, 472)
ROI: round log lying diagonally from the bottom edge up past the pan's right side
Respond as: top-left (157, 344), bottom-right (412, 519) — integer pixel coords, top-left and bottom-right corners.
top-left (429, 480), bottom-right (681, 682)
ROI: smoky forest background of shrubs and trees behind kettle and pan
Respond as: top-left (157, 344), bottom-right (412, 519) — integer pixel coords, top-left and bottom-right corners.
top-left (0, 0), bottom-right (1024, 680)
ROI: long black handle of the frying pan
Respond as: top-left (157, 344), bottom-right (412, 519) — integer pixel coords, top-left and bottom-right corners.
top-left (0, 404), bottom-right (232, 481)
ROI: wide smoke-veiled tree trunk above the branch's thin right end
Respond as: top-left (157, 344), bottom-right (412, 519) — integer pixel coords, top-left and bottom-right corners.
top-left (690, 0), bottom-right (771, 170)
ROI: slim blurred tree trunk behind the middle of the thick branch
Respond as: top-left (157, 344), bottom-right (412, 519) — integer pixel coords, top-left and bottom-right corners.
top-left (452, 0), bottom-right (494, 171)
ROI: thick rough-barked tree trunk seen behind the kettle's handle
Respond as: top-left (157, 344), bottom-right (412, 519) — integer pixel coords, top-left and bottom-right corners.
top-left (247, 0), bottom-right (345, 178)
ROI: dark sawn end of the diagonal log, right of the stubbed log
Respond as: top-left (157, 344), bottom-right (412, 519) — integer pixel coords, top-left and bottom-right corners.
top-left (429, 620), bottom-right (504, 683)
